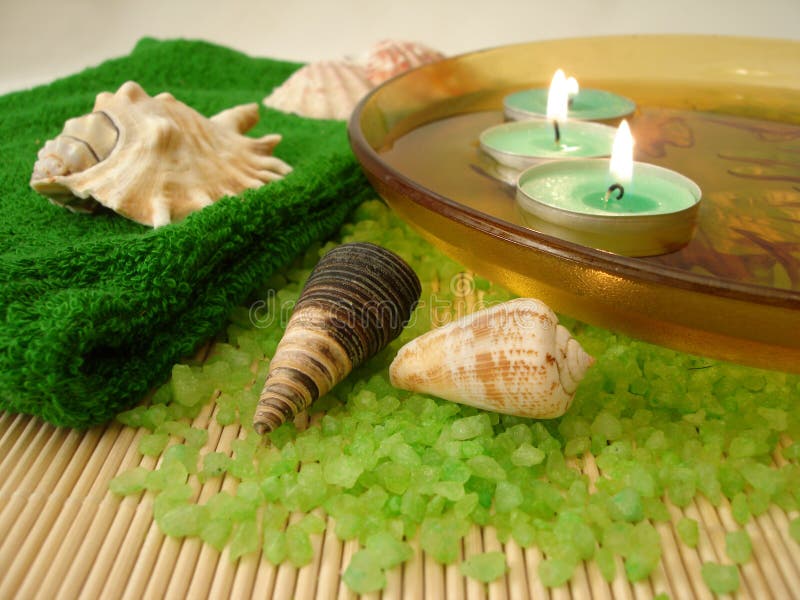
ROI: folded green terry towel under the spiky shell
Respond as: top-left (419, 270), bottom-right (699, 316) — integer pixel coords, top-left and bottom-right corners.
top-left (0, 39), bottom-right (370, 428)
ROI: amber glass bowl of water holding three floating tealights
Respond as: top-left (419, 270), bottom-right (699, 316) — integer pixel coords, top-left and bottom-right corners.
top-left (349, 36), bottom-right (800, 372)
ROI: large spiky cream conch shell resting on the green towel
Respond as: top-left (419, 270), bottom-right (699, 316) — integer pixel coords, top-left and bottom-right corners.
top-left (31, 81), bottom-right (291, 227)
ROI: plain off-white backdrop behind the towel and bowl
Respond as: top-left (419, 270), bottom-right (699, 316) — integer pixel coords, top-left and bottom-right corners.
top-left (0, 0), bottom-right (800, 93)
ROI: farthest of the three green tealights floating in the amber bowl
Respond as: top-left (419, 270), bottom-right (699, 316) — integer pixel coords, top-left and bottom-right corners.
top-left (503, 69), bottom-right (636, 121)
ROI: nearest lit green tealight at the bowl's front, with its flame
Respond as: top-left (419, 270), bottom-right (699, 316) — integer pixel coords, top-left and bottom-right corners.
top-left (517, 121), bottom-right (701, 256)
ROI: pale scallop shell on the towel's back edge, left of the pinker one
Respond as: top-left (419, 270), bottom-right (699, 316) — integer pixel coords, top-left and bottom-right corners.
top-left (264, 60), bottom-right (372, 119)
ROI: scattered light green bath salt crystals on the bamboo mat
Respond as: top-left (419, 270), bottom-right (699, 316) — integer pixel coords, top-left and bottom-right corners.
top-left (110, 201), bottom-right (800, 593)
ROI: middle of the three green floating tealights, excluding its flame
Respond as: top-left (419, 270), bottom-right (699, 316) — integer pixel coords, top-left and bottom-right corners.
top-left (480, 121), bottom-right (615, 169)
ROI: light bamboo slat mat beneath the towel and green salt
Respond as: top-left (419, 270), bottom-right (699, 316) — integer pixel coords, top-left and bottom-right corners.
top-left (0, 274), bottom-right (800, 600)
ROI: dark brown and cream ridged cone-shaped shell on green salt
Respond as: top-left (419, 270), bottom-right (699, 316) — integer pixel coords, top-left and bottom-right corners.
top-left (253, 243), bottom-right (421, 434)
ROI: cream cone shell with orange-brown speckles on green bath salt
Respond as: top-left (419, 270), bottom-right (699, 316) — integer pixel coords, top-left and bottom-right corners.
top-left (389, 298), bottom-right (594, 419)
